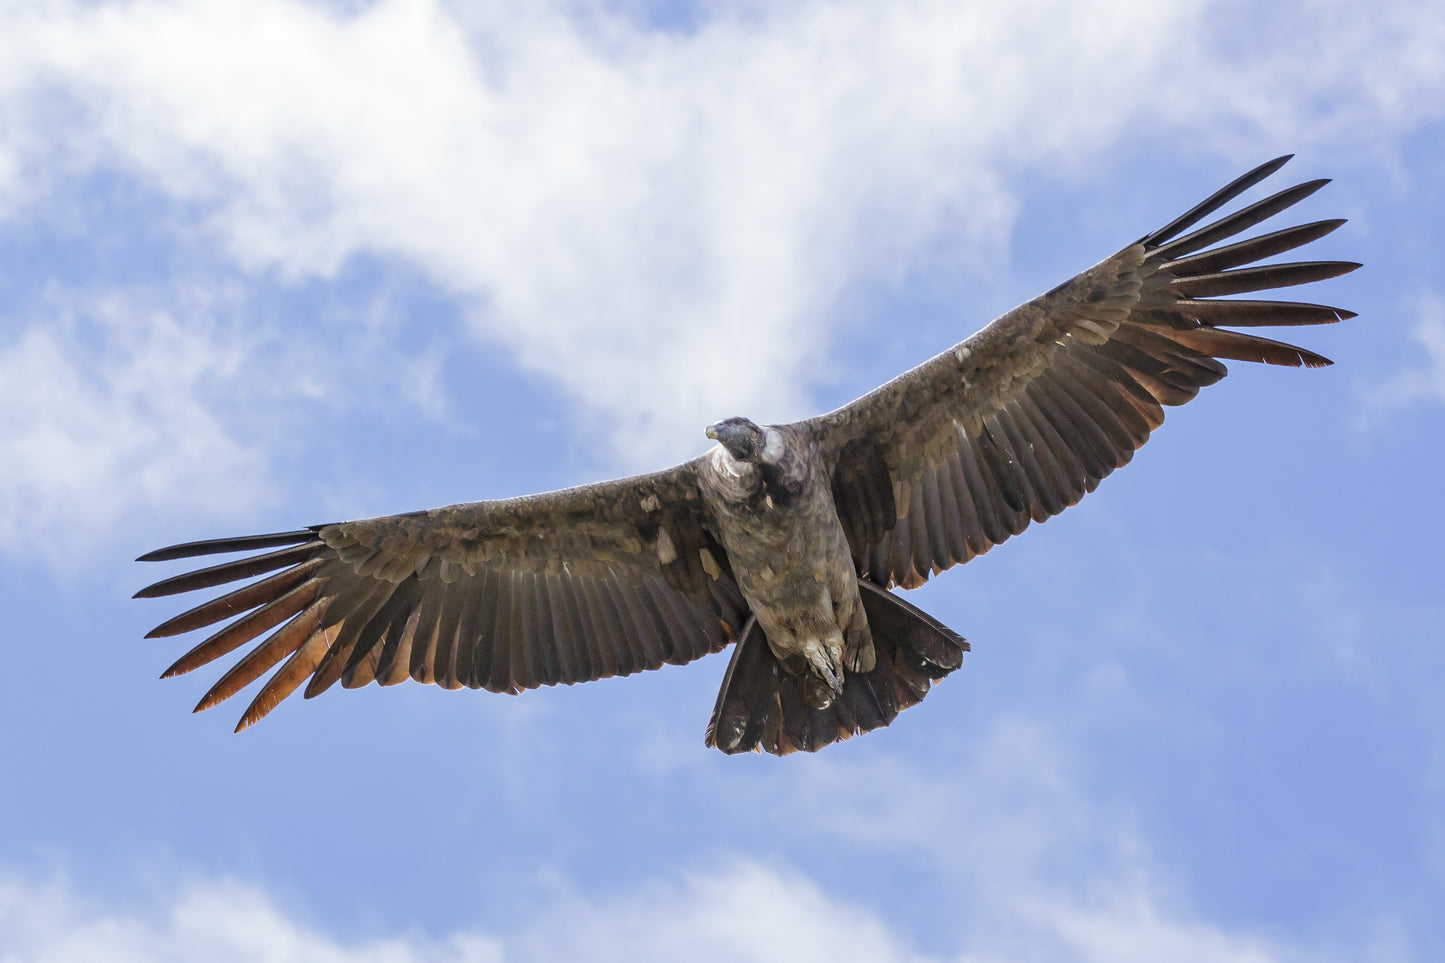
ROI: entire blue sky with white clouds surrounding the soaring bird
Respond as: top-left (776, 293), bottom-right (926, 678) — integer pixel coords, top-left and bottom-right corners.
top-left (0, 0), bottom-right (1445, 963)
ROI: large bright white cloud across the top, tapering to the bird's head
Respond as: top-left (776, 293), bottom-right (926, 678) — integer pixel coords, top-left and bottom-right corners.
top-left (0, 0), bottom-right (1445, 466)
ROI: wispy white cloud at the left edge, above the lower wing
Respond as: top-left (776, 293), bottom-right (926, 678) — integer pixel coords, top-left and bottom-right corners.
top-left (0, 276), bottom-right (442, 567)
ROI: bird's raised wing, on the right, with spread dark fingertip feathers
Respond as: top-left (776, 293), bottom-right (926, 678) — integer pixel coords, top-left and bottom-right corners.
top-left (803, 156), bottom-right (1360, 589)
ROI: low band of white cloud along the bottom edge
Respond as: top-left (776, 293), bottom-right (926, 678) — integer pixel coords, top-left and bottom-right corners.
top-left (0, 860), bottom-right (1318, 963)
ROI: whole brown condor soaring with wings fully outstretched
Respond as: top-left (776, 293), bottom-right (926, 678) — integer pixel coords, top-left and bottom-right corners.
top-left (136, 156), bottom-right (1360, 755)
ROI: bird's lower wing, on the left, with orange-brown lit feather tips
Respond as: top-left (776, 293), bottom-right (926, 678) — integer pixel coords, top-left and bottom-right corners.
top-left (136, 463), bottom-right (747, 732)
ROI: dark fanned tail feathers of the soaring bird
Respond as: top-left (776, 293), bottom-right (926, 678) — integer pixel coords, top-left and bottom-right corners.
top-left (707, 578), bottom-right (968, 755)
